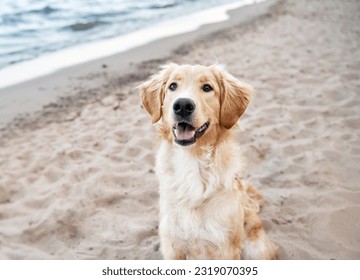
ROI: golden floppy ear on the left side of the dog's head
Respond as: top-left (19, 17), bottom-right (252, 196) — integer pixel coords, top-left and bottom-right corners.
top-left (138, 63), bottom-right (176, 123)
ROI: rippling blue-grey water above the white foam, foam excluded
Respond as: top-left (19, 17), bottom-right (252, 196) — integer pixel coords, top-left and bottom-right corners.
top-left (0, 0), bottom-right (241, 69)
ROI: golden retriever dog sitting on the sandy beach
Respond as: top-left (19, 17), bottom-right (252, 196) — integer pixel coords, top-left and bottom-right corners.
top-left (139, 64), bottom-right (276, 259)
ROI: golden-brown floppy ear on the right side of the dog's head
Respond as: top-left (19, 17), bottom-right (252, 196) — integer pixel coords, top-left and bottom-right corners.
top-left (220, 69), bottom-right (254, 129)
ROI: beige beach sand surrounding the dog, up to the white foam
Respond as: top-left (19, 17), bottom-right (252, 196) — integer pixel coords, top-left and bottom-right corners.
top-left (0, 0), bottom-right (360, 259)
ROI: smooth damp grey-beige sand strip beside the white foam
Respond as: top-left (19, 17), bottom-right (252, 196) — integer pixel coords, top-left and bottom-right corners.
top-left (0, 0), bottom-right (277, 131)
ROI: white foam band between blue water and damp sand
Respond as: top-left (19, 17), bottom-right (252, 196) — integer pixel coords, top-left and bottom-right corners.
top-left (0, 0), bottom-right (264, 88)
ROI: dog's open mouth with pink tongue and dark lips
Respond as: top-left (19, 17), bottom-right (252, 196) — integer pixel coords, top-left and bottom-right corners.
top-left (173, 122), bottom-right (209, 146)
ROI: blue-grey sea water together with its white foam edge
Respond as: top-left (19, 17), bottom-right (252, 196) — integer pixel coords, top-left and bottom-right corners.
top-left (0, 0), bottom-right (254, 87)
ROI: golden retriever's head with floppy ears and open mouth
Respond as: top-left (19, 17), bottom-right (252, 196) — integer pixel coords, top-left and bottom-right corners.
top-left (139, 64), bottom-right (252, 146)
